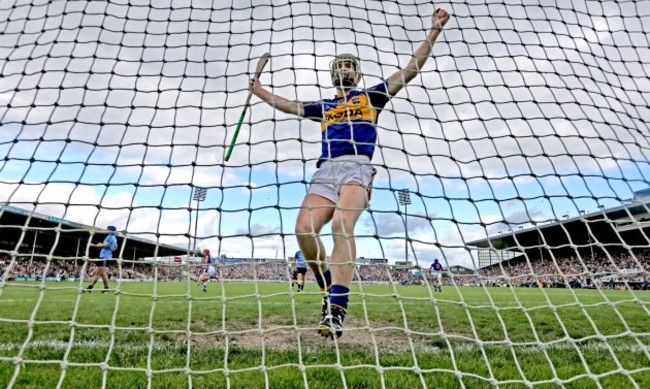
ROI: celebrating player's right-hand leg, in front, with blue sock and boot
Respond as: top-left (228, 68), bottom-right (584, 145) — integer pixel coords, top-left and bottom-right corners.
top-left (319, 182), bottom-right (368, 337)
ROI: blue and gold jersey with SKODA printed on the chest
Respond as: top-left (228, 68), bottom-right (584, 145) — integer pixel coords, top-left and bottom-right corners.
top-left (304, 82), bottom-right (391, 165)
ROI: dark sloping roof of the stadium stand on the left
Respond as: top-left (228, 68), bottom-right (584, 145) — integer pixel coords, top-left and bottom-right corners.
top-left (0, 204), bottom-right (188, 260)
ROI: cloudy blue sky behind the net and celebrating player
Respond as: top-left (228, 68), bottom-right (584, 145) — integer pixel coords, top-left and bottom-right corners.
top-left (0, 0), bottom-right (650, 266)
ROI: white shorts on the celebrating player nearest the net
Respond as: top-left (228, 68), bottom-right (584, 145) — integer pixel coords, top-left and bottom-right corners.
top-left (309, 155), bottom-right (377, 203)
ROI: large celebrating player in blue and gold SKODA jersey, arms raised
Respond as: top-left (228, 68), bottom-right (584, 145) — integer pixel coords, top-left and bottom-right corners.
top-left (250, 8), bottom-right (450, 338)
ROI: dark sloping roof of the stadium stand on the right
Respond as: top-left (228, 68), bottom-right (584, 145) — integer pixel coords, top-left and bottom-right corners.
top-left (467, 196), bottom-right (650, 257)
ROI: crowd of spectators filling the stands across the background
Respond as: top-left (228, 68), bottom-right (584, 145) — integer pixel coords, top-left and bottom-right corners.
top-left (0, 250), bottom-right (650, 289)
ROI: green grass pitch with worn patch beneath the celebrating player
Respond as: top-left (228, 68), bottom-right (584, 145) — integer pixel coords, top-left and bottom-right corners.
top-left (0, 282), bottom-right (650, 389)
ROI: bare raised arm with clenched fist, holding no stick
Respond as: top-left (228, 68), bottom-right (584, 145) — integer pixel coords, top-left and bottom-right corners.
top-left (386, 8), bottom-right (449, 96)
